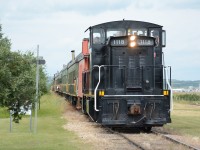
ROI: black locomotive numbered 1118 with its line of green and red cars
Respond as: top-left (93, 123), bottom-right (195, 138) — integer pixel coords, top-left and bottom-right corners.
top-left (53, 20), bottom-right (172, 131)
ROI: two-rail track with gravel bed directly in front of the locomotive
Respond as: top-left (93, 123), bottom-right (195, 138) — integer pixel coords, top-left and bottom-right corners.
top-left (106, 127), bottom-right (200, 150)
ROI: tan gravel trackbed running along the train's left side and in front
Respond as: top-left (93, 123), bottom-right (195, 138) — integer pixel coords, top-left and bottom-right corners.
top-left (63, 96), bottom-right (198, 150)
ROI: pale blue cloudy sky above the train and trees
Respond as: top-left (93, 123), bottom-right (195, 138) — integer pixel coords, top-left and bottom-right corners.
top-left (0, 0), bottom-right (200, 80)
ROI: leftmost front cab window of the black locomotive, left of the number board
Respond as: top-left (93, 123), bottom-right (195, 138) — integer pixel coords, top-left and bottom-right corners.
top-left (93, 29), bottom-right (105, 44)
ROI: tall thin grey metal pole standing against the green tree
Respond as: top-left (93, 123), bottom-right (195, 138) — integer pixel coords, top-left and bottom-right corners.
top-left (34, 45), bottom-right (39, 133)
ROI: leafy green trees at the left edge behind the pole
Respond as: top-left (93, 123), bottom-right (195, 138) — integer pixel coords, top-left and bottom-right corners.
top-left (0, 25), bottom-right (47, 122)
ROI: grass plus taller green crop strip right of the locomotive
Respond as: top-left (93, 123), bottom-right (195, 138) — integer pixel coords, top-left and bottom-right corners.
top-left (165, 94), bottom-right (200, 138)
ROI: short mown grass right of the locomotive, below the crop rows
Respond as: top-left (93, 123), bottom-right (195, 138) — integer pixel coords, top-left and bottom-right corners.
top-left (165, 101), bottom-right (200, 138)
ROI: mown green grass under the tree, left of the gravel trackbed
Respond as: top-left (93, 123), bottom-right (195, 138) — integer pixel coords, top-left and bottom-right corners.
top-left (0, 94), bottom-right (90, 150)
